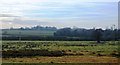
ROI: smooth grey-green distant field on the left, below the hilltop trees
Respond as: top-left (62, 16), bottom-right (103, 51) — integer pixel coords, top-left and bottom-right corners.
top-left (2, 30), bottom-right (55, 36)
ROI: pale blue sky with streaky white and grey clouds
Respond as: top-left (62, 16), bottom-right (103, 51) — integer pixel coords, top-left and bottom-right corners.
top-left (0, 0), bottom-right (118, 28)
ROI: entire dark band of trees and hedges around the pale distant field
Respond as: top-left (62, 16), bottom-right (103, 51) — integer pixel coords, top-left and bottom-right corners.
top-left (2, 26), bottom-right (120, 43)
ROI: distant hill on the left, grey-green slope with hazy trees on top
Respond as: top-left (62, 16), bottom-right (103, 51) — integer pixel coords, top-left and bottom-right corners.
top-left (2, 26), bottom-right (57, 37)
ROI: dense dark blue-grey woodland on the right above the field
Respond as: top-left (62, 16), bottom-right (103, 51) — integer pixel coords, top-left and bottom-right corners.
top-left (54, 28), bottom-right (120, 43)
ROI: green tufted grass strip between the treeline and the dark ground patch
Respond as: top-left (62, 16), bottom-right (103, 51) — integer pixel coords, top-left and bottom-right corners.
top-left (2, 41), bottom-right (119, 55)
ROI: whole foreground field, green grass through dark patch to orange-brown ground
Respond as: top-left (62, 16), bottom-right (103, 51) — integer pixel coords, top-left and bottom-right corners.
top-left (2, 41), bottom-right (119, 63)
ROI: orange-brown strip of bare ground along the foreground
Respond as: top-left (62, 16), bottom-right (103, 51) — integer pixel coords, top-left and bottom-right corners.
top-left (3, 56), bottom-right (118, 63)
